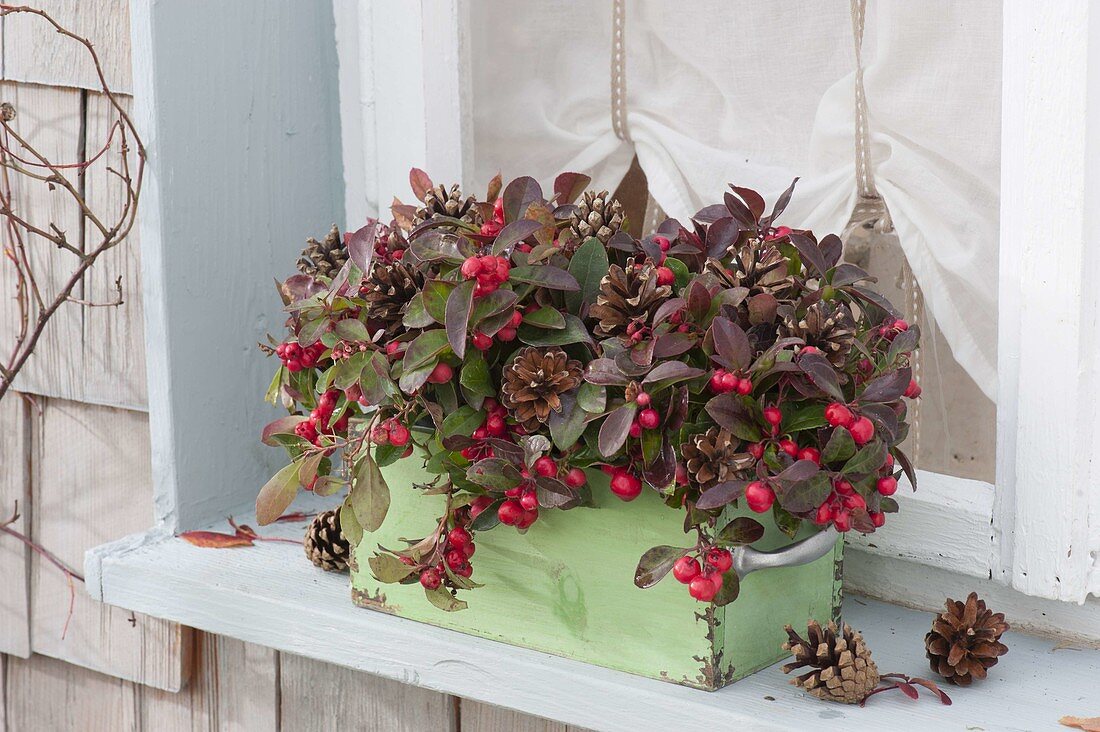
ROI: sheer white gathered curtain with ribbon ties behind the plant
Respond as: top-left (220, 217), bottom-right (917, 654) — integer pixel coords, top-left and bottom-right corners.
top-left (469, 0), bottom-right (1001, 398)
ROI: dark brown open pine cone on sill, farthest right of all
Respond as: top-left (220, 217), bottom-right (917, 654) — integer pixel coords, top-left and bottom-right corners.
top-left (924, 592), bottom-right (1009, 686)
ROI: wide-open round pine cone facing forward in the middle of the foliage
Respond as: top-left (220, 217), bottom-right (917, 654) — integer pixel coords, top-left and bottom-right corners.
top-left (501, 348), bottom-right (583, 433)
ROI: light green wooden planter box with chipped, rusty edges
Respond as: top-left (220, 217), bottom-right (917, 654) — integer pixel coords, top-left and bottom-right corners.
top-left (352, 460), bottom-right (843, 689)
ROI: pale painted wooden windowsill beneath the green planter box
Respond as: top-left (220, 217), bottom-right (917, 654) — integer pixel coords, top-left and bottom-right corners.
top-left (86, 499), bottom-right (1100, 732)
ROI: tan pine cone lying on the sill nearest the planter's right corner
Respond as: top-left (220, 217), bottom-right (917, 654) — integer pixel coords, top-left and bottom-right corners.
top-left (783, 620), bottom-right (879, 704)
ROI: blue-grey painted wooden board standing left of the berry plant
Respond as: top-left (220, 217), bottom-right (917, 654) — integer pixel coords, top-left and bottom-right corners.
top-left (132, 0), bottom-right (343, 529)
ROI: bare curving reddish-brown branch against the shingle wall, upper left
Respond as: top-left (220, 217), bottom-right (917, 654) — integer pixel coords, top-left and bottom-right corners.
top-left (0, 3), bottom-right (145, 400)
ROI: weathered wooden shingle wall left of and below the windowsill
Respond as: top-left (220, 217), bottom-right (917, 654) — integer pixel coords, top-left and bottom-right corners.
top-left (0, 0), bottom-right (568, 732)
